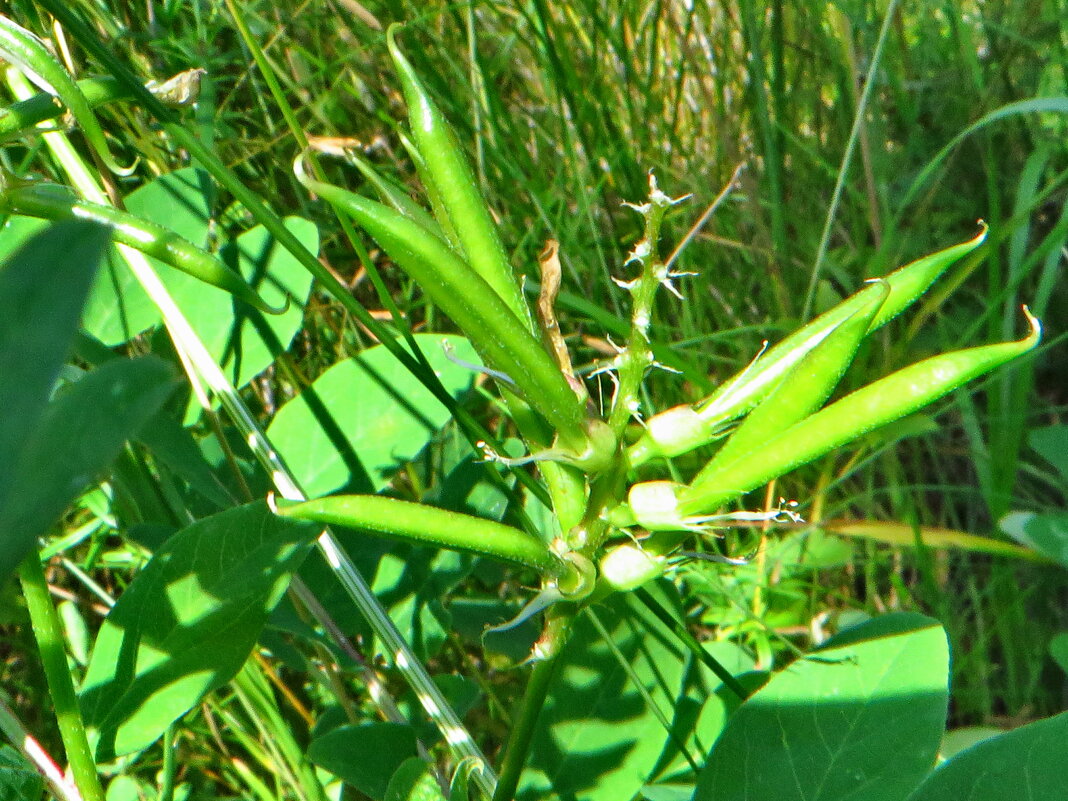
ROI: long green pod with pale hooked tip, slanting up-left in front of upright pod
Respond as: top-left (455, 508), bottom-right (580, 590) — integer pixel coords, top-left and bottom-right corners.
top-left (294, 165), bottom-right (588, 455)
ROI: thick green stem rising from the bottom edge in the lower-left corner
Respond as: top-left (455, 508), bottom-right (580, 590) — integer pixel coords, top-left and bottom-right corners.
top-left (18, 550), bottom-right (105, 801)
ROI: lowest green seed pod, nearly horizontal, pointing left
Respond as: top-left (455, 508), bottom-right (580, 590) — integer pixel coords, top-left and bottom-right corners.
top-left (270, 496), bottom-right (569, 577)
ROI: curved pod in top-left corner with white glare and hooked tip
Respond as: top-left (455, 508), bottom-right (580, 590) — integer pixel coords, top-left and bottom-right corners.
top-left (0, 15), bottom-right (137, 175)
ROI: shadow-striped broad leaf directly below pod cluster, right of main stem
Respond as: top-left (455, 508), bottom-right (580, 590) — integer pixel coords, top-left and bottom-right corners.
top-left (517, 594), bottom-right (687, 801)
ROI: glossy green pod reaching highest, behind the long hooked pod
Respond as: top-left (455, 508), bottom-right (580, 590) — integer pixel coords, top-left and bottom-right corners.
top-left (386, 23), bottom-right (533, 330)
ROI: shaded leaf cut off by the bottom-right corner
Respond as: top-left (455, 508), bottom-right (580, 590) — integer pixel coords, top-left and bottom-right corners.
top-left (909, 712), bottom-right (1068, 801)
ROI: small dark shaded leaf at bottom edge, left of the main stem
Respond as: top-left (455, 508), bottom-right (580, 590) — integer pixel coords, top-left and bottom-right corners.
top-left (308, 723), bottom-right (415, 801)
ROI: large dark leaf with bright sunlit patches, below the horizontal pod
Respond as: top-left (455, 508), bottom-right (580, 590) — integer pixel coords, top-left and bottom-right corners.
top-left (81, 502), bottom-right (319, 760)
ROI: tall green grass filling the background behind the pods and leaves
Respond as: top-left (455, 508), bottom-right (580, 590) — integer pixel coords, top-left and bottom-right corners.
top-left (6, 0), bottom-right (1068, 795)
